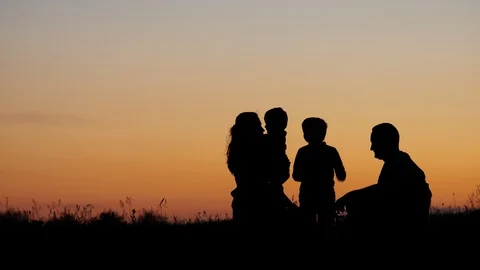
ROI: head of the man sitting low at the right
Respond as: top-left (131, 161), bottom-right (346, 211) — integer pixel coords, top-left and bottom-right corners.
top-left (370, 123), bottom-right (400, 160)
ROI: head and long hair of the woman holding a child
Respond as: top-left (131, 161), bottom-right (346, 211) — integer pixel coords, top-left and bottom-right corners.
top-left (227, 112), bottom-right (265, 173)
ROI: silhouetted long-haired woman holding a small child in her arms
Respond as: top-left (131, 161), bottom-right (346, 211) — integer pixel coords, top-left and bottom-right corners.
top-left (227, 112), bottom-right (269, 224)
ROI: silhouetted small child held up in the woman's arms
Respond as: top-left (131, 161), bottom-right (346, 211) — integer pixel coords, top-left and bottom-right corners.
top-left (264, 107), bottom-right (296, 216)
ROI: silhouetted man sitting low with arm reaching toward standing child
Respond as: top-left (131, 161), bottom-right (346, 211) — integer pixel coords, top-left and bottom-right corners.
top-left (337, 123), bottom-right (432, 233)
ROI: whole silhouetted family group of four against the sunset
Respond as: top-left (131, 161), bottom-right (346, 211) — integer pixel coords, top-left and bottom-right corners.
top-left (226, 107), bottom-right (432, 236)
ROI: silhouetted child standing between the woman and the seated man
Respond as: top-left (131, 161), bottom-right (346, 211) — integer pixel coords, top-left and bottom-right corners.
top-left (292, 117), bottom-right (346, 232)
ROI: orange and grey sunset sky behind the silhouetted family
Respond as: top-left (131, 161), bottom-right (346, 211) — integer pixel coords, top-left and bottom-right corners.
top-left (0, 0), bottom-right (480, 217)
